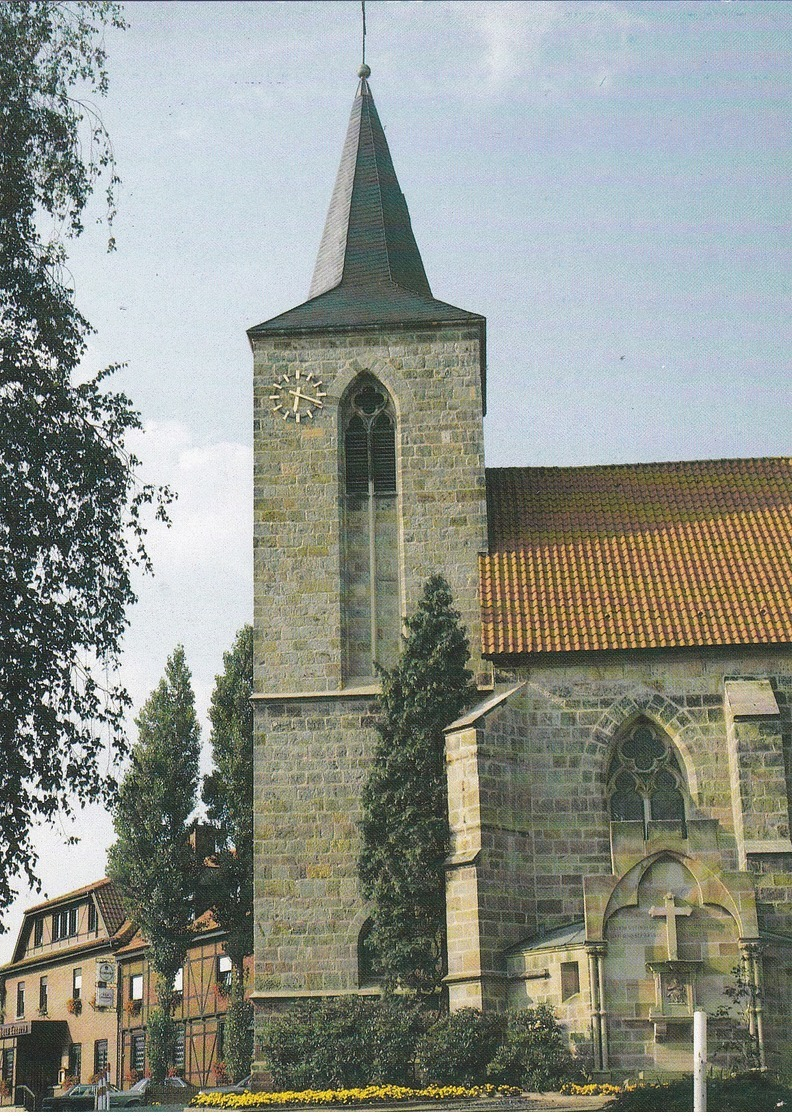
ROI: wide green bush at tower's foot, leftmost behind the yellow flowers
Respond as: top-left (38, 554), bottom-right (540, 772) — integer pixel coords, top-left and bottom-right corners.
top-left (261, 995), bottom-right (427, 1089)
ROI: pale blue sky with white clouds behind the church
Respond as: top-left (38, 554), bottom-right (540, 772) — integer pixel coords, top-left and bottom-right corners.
top-left (0, 0), bottom-right (792, 961)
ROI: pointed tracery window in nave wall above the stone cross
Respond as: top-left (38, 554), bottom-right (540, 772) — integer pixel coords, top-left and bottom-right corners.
top-left (608, 719), bottom-right (685, 826)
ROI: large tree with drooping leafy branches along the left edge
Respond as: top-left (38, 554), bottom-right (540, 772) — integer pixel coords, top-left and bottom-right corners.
top-left (0, 0), bottom-right (170, 930)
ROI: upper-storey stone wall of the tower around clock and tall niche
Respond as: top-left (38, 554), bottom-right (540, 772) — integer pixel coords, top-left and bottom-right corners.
top-left (253, 326), bottom-right (489, 693)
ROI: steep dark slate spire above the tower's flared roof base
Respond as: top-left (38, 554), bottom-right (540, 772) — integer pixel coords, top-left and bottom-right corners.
top-left (308, 71), bottom-right (432, 298)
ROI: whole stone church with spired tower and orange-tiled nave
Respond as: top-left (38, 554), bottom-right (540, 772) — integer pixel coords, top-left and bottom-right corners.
top-left (250, 66), bottom-right (792, 1076)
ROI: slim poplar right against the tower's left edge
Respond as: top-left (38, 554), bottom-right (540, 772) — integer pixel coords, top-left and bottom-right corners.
top-left (203, 624), bottom-right (253, 1081)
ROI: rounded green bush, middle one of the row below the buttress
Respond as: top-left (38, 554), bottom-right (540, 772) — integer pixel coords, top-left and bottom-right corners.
top-left (415, 1008), bottom-right (504, 1085)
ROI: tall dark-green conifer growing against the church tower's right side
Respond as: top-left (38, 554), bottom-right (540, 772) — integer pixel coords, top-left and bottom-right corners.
top-left (358, 574), bottom-right (476, 994)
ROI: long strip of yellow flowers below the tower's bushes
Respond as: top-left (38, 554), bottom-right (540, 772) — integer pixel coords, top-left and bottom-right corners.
top-left (190, 1085), bottom-right (520, 1108)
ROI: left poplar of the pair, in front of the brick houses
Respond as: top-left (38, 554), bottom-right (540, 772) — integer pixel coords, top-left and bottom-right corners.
top-left (107, 646), bottom-right (202, 1081)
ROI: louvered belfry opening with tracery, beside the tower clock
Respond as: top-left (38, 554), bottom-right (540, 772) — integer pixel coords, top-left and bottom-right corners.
top-left (344, 376), bottom-right (396, 496)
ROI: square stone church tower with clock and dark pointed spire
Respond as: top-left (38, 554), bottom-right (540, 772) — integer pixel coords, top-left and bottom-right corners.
top-left (249, 65), bottom-right (489, 1026)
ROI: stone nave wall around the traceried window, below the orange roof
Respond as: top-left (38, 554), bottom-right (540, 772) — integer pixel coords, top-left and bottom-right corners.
top-left (452, 648), bottom-right (792, 1053)
